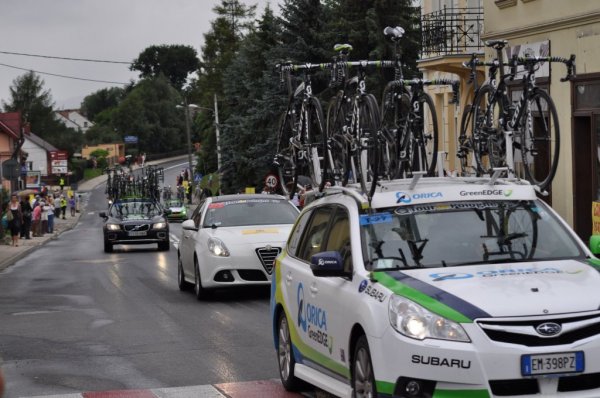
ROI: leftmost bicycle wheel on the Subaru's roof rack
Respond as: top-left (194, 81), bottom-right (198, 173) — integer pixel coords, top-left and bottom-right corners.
top-left (275, 112), bottom-right (298, 199)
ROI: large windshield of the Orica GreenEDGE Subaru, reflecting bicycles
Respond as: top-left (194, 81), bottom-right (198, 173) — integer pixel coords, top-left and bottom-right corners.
top-left (360, 201), bottom-right (585, 270)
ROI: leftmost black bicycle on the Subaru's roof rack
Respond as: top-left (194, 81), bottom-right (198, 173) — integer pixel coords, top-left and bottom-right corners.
top-left (274, 62), bottom-right (328, 199)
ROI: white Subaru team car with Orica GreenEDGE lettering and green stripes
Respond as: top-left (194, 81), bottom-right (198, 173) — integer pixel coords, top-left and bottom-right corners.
top-left (271, 177), bottom-right (600, 398)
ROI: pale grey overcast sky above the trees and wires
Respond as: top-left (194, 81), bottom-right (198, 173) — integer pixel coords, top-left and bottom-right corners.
top-left (0, 0), bottom-right (278, 109)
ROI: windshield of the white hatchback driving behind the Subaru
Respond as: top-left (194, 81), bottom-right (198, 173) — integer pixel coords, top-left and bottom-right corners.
top-left (203, 199), bottom-right (298, 227)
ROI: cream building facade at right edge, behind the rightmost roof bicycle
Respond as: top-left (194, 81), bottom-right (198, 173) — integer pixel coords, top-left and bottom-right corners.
top-left (482, 0), bottom-right (600, 240)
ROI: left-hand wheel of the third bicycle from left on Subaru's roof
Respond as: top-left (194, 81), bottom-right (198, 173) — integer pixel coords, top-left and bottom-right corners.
top-left (380, 82), bottom-right (410, 179)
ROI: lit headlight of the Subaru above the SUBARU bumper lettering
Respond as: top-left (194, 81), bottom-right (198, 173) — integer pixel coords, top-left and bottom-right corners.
top-left (389, 295), bottom-right (471, 342)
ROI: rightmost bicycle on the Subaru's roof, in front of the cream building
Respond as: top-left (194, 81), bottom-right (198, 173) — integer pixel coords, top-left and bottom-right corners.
top-left (461, 40), bottom-right (576, 192)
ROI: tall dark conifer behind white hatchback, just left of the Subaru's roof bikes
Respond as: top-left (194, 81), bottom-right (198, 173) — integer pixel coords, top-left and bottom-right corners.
top-left (220, 7), bottom-right (281, 192)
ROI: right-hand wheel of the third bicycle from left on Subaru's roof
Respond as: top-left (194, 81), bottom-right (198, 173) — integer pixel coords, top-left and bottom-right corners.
top-left (403, 93), bottom-right (439, 177)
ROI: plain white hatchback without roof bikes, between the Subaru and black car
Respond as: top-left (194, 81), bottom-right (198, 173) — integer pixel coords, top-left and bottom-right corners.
top-left (177, 195), bottom-right (299, 300)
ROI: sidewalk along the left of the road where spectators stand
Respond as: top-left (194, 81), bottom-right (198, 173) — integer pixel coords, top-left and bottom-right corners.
top-left (0, 155), bottom-right (187, 272)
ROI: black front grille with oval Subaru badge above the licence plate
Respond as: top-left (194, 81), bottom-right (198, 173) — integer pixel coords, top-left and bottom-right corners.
top-left (477, 313), bottom-right (600, 347)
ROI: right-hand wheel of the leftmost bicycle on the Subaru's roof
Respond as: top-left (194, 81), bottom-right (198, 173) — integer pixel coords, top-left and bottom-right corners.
top-left (305, 97), bottom-right (327, 191)
